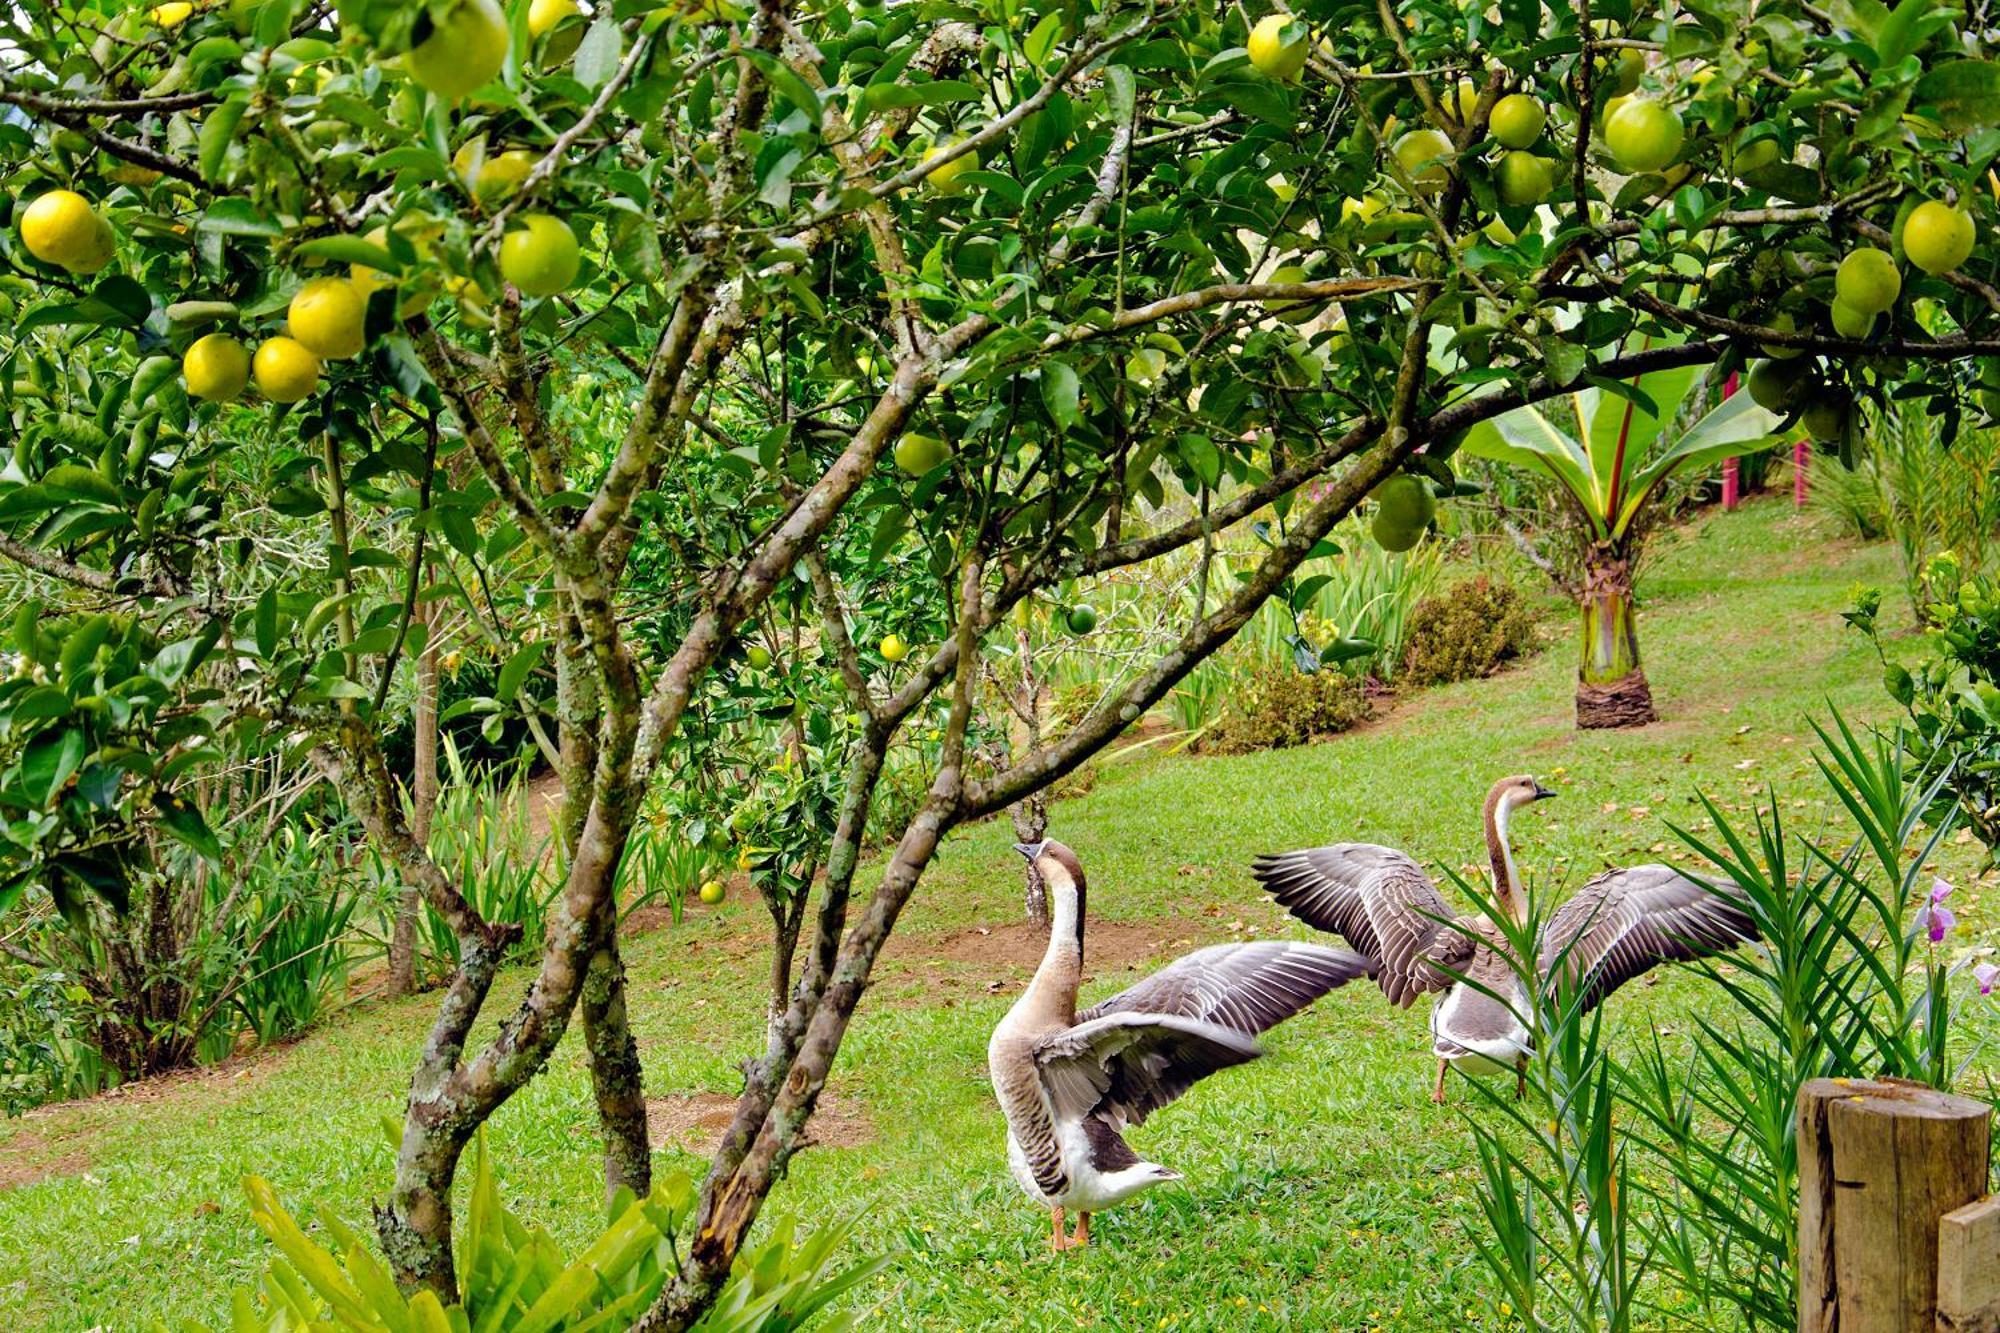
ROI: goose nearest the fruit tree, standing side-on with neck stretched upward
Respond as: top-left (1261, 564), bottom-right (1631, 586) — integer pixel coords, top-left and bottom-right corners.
top-left (986, 841), bottom-right (1368, 1251)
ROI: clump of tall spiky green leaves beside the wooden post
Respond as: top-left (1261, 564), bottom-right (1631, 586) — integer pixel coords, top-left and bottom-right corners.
top-left (1472, 715), bottom-right (1992, 1329)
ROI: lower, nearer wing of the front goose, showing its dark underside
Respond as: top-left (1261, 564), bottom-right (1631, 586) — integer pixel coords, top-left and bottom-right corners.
top-left (1034, 1011), bottom-right (1258, 1131)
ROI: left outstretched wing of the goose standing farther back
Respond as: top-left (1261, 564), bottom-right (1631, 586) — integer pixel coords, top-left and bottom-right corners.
top-left (1250, 843), bottom-right (1474, 1009)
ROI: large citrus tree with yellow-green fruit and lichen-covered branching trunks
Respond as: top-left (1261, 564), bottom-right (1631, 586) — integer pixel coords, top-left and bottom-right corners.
top-left (0, 0), bottom-right (2000, 1329)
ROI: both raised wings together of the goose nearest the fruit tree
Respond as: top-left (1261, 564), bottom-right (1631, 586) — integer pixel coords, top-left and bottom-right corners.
top-left (1034, 939), bottom-right (1368, 1129)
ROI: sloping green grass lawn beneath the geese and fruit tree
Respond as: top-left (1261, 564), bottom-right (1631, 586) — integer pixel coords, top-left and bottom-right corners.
top-left (0, 500), bottom-right (2000, 1333)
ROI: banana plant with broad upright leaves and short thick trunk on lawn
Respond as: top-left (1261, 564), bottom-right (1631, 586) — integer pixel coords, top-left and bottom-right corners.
top-left (1460, 356), bottom-right (1784, 727)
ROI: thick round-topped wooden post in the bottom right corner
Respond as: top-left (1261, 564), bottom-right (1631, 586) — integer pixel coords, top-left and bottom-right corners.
top-left (1798, 1079), bottom-right (1992, 1333)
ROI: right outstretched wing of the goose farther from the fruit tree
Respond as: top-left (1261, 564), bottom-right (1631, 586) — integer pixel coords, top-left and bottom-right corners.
top-left (1540, 865), bottom-right (1758, 1009)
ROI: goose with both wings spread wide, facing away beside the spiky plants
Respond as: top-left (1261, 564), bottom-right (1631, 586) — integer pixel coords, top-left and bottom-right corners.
top-left (1252, 777), bottom-right (1756, 1103)
